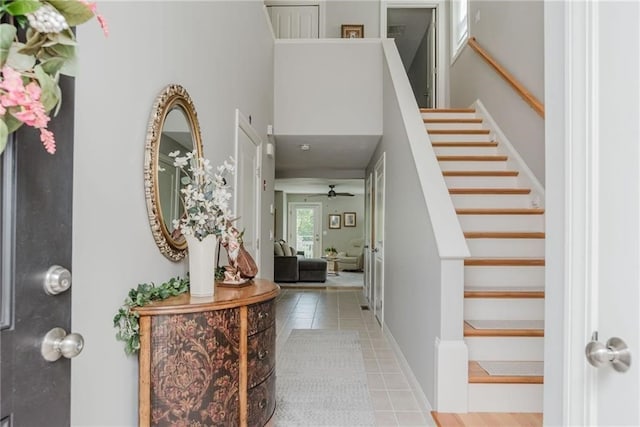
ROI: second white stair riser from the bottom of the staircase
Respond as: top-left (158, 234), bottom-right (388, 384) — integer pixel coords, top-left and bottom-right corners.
top-left (464, 337), bottom-right (544, 361)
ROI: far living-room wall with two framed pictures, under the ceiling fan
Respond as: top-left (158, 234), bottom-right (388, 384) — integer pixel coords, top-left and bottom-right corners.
top-left (287, 193), bottom-right (364, 252)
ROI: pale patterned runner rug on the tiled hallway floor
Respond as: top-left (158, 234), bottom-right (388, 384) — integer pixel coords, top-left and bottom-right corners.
top-left (275, 329), bottom-right (375, 427)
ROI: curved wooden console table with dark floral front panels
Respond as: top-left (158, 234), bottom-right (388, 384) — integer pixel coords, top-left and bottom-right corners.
top-left (137, 279), bottom-right (280, 426)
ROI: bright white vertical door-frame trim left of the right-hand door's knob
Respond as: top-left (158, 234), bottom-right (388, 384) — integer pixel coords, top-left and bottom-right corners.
top-left (560, 2), bottom-right (598, 425)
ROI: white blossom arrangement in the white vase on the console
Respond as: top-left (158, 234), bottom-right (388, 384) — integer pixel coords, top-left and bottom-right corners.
top-left (169, 151), bottom-right (235, 242)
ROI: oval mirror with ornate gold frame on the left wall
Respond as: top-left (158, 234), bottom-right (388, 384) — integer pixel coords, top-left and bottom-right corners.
top-left (144, 84), bottom-right (202, 261)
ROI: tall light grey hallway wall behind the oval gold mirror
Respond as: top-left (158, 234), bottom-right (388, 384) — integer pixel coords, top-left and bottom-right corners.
top-left (71, 1), bottom-right (274, 426)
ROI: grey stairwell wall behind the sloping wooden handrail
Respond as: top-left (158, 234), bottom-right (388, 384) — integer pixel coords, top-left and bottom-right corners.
top-left (450, 0), bottom-right (545, 185)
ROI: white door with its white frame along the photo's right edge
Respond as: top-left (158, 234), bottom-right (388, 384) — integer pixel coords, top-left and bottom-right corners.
top-left (544, 2), bottom-right (640, 426)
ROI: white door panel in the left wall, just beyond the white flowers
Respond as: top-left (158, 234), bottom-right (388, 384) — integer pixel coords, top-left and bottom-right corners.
top-left (234, 110), bottom-right (262, 271)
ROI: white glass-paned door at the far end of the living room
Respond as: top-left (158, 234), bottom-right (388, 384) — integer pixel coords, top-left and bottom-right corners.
top-left (288, 202), bottom-right (322, 258)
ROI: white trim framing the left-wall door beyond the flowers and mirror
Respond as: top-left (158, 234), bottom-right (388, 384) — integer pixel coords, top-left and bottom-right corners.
top-left (233, 108), bottom-right (266, 271)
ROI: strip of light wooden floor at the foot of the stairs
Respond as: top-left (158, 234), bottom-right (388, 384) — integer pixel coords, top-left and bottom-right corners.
top-left (431, 411), bottom-right (542, 427)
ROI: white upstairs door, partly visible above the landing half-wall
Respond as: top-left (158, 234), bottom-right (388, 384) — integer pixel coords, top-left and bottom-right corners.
top-left (267, 6), bottom-right (319, 39)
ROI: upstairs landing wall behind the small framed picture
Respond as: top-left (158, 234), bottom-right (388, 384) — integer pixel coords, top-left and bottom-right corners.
top-left (325, 0), bottom-right (380, 38)
